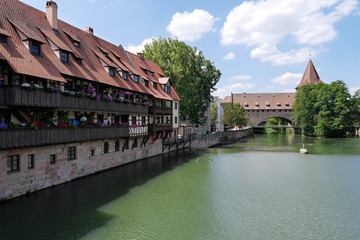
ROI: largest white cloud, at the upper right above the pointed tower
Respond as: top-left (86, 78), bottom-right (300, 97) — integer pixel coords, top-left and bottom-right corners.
top-left (221, 0), bottom-right (358, 65)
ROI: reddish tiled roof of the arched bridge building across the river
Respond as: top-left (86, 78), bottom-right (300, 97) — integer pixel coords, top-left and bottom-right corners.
top-left (221, 93), bottom-right (295, 110)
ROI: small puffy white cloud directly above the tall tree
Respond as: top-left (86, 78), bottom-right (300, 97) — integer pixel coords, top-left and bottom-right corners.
top-left (166, 9), bottom-right (217, 42)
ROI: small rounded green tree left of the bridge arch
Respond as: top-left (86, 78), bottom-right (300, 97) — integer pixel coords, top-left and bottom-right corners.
top-left (222, 103), bottom-right (249, 128)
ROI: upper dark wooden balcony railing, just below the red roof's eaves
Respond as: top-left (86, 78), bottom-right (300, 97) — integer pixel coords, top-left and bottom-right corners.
top-left (0, 86), bottom-right (148, 114)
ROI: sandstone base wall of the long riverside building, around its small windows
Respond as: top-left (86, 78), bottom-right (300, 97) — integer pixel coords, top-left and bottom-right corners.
top-left (0, 138), bottom-right (162, 200)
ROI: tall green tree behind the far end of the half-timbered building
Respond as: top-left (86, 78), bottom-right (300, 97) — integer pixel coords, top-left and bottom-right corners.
top-left (143, 37), bottom-right (221, 126)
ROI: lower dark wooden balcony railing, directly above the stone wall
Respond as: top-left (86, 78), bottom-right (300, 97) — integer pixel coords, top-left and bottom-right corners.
top-left (0, 126), bottom-right (130, 150)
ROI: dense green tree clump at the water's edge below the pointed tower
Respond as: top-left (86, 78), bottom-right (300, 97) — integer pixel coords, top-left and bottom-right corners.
top-left (293, 80), bottom-right (360, 137)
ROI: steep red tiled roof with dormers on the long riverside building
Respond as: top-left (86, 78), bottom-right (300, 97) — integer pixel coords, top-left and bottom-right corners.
top-left (0, 0), bottom-right (179, 99)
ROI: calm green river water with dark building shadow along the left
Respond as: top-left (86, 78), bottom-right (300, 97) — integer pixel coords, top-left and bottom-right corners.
top-left (0, 134), bottom-right (360, 240)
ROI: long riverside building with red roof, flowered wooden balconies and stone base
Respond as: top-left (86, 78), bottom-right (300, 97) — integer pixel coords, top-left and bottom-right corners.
top-left (0, 0), bottom-right (180, 200)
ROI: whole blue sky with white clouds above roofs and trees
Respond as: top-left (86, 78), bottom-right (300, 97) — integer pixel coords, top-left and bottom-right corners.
top-left (23, 0), bottom-right (360, 97)
